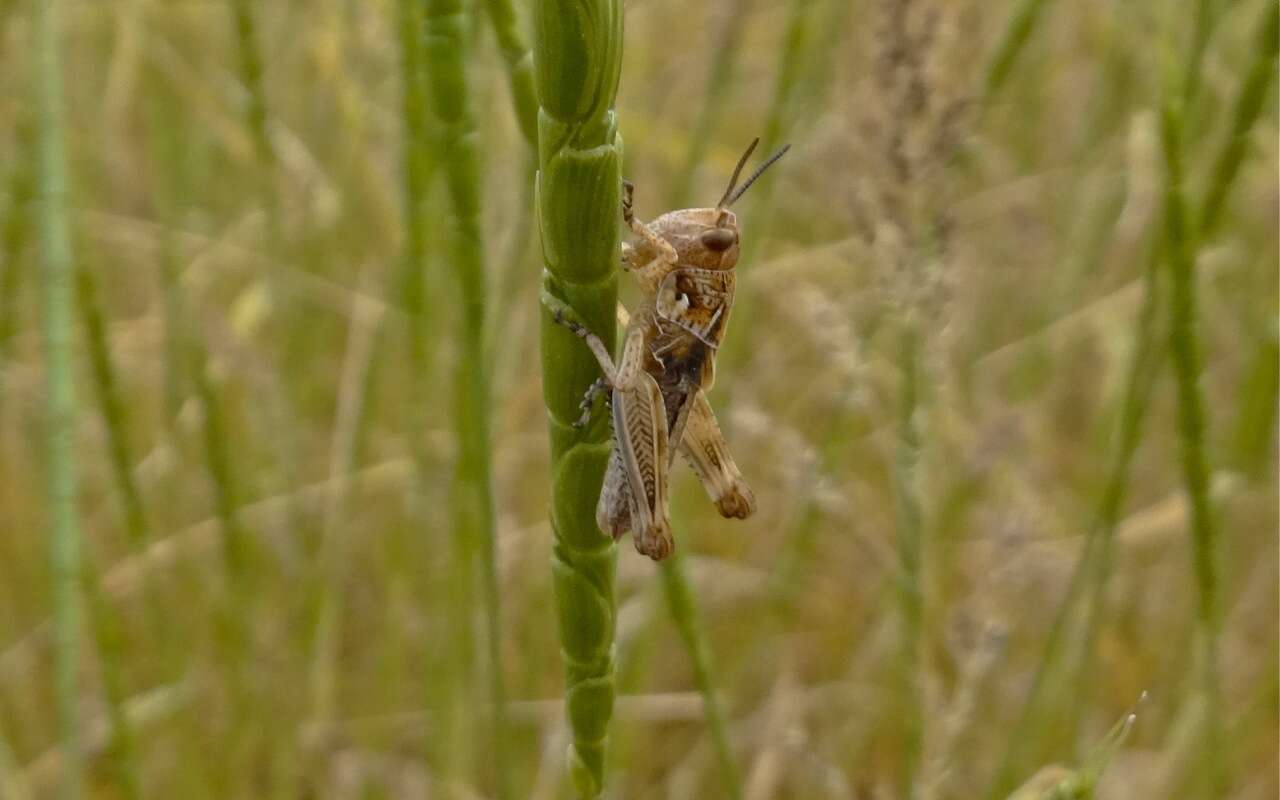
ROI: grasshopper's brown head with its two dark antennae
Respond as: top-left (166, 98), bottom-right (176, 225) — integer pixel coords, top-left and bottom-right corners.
top-left (653, 138), bottom-right (790, 270)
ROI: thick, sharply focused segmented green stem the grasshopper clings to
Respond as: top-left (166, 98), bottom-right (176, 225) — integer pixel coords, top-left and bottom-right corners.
top-left (534, 0), bottom-right (622, 797)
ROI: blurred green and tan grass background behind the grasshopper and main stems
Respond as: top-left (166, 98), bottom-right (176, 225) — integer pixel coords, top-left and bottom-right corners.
top-left (0, 0), bottom-right (1280, 800)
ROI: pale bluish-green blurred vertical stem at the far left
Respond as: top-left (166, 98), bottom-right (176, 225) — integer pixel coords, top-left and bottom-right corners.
top-left (33, 0), bottom-right (83, 800)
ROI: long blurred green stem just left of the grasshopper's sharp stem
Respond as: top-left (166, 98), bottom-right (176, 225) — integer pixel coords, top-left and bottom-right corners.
top-left (424, 0), bottom-right (511, 797)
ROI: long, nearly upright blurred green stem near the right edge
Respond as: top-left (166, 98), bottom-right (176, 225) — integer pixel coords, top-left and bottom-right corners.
top-left (1160, 88), bottom-right (1224, 797)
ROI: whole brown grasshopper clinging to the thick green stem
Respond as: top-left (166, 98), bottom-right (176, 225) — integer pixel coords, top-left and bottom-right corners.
top-left (553, 138), bottom-right (787, 561)
